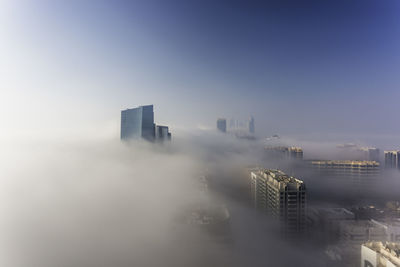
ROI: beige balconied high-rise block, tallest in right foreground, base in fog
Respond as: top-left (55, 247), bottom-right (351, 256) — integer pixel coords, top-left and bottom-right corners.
top-left (251, 169), bottom-right (306, 235)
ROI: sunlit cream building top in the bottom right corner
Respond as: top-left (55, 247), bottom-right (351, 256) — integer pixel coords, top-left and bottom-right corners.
top-left (361, 242), bottom-right (400, 267)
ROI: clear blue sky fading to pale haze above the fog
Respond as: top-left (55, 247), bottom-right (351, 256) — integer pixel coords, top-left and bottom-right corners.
top-left (0, 0), bottom-right (400, 142)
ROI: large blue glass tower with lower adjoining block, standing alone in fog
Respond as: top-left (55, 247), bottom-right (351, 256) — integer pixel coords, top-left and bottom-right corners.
top-left (121, 105), bottom-right (171, 142)
